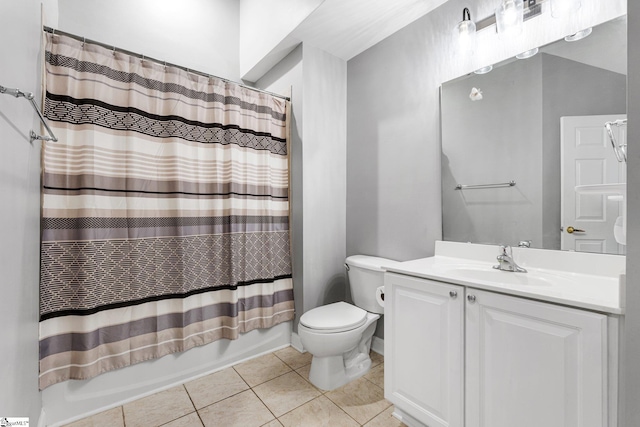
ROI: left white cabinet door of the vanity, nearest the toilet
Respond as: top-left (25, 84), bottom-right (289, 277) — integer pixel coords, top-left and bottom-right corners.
top-left (384, 273), bottom-right (464, 427)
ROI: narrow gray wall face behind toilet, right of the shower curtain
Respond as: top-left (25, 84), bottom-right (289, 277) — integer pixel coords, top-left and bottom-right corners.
top-left (303, 44), bottom-right (347, 311)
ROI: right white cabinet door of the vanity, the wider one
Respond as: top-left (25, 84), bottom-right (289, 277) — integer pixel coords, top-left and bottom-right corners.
top-left (465, 289), bottom-right (607, 427)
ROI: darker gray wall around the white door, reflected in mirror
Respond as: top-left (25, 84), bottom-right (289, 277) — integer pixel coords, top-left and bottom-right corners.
top-left (542, 55), bottom-right (627, 249)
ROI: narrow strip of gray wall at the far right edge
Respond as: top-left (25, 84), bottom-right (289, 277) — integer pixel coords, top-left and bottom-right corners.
top-left (620, 1), bottom-right (640, 427)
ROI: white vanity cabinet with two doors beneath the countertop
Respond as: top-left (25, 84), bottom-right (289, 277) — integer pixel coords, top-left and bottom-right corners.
top-left (385, 273), bottom-right (609, 427)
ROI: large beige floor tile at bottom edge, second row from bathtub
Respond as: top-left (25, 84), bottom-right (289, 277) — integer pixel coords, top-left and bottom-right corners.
top-left (198, 390), bottom-right (274, 427)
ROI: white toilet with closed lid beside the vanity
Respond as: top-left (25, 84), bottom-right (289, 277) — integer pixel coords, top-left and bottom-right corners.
top-left (298, 255), bottom-right (396, 390)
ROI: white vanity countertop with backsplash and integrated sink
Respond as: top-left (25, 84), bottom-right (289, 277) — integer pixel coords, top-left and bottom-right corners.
top-left (385, 242), bottom-right (625, 314)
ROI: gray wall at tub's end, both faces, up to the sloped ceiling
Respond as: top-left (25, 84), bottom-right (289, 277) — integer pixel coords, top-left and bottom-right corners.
top-left (256, 44), bottom-right (347, 330)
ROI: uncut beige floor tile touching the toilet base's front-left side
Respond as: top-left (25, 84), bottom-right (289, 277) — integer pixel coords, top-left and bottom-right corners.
top-left (253, 372), bottom-right (321, 417)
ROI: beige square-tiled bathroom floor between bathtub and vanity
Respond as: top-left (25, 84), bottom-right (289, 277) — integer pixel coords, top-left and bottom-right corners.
top-left (67, 347), bottom-right (404, 427)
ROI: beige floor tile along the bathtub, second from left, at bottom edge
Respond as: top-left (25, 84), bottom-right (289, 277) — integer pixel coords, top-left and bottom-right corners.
top-left (123, 385), bottom-right (195, 427)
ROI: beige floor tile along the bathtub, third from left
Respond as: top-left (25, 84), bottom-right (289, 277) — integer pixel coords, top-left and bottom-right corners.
top-left (184, 368), bottom-right (249, 409)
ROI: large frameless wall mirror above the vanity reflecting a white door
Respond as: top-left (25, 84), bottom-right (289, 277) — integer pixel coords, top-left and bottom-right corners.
top-left (441, 17), bottom-right (627, 254)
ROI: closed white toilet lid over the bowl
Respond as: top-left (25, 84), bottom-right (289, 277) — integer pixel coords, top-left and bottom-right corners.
top-left (300, 302), bottom-right (367, 332)
